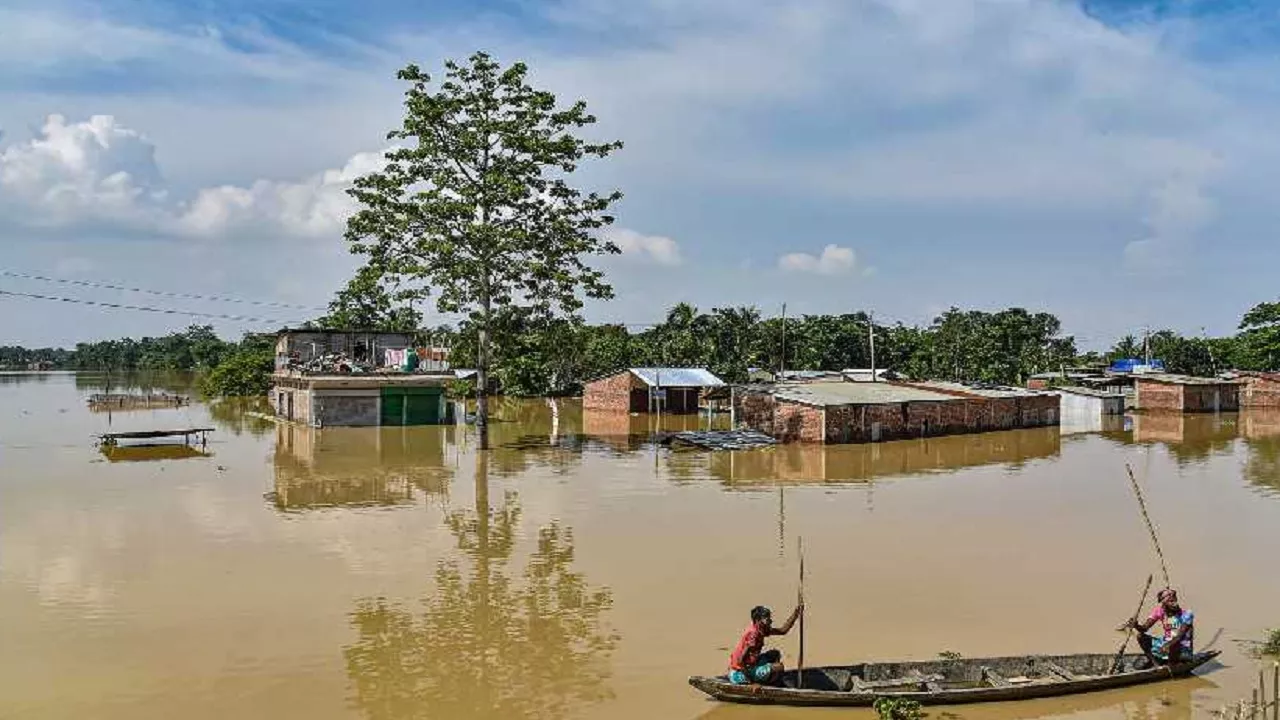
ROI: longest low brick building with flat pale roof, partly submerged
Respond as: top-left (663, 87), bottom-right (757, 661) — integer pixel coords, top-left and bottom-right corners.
top-left (733, 382), bottom-right (1059, 443)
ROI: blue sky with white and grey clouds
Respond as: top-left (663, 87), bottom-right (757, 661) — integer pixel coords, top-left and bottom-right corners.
top-left (0, 0), bottom-right (1280, 348)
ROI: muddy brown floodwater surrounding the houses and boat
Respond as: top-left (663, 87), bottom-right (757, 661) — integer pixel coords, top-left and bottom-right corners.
top-left (0, 374), bottom-right (1280, 720)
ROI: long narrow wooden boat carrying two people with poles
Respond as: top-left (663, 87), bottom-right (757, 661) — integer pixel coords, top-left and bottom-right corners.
top-left (689, 650), bottom-right (1221, 706)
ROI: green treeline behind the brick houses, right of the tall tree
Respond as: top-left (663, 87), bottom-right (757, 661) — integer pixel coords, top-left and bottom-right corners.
top-left (434, 304), bottom-right (1280, 395)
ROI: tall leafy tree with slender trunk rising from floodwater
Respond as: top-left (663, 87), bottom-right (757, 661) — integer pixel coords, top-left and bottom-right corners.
top-left (347, 53), bottom-right (622, 445)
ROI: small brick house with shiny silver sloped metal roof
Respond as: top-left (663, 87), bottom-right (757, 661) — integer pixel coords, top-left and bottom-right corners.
top-left (582, 368), bottom-right (724, 415)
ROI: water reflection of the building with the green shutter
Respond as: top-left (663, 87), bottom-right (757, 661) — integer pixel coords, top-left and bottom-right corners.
top-left (266, 424), bottom-right (456, 511)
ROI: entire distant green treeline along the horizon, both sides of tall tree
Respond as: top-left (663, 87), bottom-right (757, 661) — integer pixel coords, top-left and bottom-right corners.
top-left (0, 297), bottom-right (1280, 396)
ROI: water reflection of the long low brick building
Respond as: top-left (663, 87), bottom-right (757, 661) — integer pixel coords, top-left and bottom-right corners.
top-left (686, 427), bottom-right (1062, 486)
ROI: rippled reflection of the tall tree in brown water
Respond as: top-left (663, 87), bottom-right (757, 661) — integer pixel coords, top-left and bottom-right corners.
top-left (344, 452), bottom-right (620, 720)
